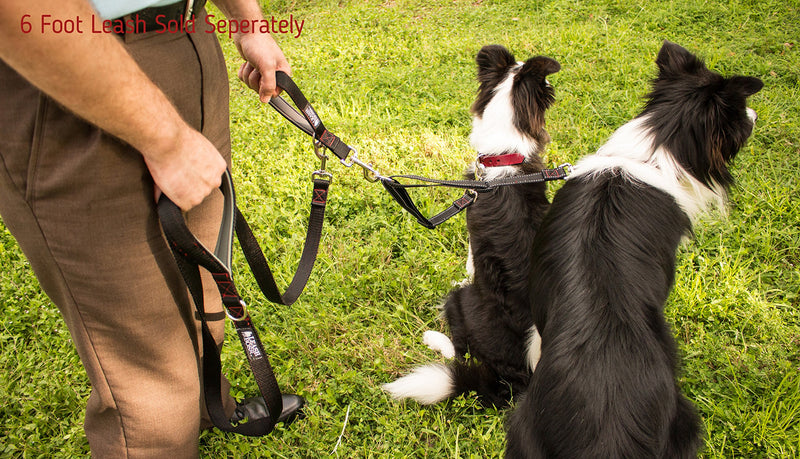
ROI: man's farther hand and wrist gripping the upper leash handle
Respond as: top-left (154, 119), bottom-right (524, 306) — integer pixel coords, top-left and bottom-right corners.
top-left (214, 0), bottom-right (292, 103)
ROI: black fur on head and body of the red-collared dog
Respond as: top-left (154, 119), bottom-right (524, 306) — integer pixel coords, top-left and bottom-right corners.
top-left (444, 47), bottom-right (560, 406)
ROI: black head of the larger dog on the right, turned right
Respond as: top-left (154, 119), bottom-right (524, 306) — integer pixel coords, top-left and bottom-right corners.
top-left (640, 41), bottom-right (764, 188)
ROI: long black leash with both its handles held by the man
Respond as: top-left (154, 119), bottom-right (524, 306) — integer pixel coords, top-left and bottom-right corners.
top-left (158, 72), bottom-right (361, 436)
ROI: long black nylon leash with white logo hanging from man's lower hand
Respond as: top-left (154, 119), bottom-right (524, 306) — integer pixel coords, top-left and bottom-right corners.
top-left (158, 171), bottom-right (328, 436)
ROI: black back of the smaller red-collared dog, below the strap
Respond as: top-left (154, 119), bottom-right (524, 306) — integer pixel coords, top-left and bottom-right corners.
top-left (444, 171), bottom-right (549, 406)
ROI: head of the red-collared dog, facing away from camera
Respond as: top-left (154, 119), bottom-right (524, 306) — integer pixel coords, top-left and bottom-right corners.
top-left (470, 45), bottom-right (561, 160)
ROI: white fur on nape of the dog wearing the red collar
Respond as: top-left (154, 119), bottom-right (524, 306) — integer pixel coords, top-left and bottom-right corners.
top-left (469, 68), bottom-right (539, 180)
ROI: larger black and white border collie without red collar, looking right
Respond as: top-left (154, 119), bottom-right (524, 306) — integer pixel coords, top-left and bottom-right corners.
top-left (506, 42), bottom-right (763, 458)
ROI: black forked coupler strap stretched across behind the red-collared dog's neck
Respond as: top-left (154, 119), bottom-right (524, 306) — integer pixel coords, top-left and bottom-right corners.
top-left (381, 164), bottom-right (571, 229)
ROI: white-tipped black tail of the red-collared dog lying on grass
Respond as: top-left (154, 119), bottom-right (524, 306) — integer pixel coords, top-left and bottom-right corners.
top-left (382, 360), bottom-right (511, 407)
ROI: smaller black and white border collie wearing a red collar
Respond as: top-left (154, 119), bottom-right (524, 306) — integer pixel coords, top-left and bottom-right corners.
top-left (383, 45), bottom-right (561, 406)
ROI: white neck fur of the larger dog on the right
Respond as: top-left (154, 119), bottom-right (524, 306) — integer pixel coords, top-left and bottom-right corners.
top-left (568, 117), bottom-right (725, 219)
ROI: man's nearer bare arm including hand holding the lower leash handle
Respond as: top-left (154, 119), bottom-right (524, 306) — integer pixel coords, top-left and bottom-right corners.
top-left (0, 0), bottom-right (226, 210)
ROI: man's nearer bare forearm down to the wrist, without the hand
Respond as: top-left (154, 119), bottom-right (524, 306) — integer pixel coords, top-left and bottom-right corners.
top-left (0, 0), bottom-right (186, 162)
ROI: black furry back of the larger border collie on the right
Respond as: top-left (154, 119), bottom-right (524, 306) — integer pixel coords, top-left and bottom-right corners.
top-left (507, 171), bottom-right (699, 458)
